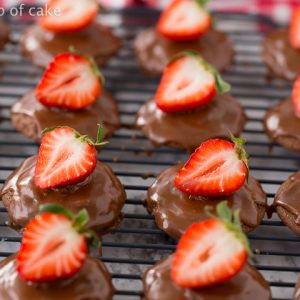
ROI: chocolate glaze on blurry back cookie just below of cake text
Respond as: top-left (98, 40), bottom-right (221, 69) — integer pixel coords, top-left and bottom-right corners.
top-left (21, 22), bottom-right (121, 67)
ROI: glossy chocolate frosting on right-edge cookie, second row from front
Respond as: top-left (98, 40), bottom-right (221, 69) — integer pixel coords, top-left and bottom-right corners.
top-left (273, 172), bottom-right (300, 230)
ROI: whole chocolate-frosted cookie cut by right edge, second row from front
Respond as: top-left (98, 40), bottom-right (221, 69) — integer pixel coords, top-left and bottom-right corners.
top-left (273, 172), bottom-right (300, 234)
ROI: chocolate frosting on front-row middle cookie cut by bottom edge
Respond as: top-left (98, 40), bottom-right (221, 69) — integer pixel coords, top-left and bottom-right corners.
top-left (143, 256), bottom-right (272, 300)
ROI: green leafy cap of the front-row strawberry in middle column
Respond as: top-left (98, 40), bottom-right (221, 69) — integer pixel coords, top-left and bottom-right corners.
top-left (205, 201), bottom-right (253, 257)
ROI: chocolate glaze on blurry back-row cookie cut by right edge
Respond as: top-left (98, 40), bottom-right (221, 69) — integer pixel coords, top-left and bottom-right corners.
top-left (262, 29), bottom-right (300, 81)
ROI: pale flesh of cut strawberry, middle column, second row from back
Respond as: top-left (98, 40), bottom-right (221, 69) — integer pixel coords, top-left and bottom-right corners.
top-left (164, 57), bottom-right (215, 103)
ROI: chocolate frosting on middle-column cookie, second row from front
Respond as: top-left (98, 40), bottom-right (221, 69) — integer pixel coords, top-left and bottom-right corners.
top-left (146, 164), bottom-right (267, 239)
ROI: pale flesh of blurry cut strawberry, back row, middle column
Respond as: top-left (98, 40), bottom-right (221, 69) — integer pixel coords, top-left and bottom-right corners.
top-left (164, 0), bottom-right (208, 33)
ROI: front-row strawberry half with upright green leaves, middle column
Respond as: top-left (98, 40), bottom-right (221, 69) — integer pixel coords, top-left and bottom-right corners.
top-left (171, 201), bottom-right (251, 288)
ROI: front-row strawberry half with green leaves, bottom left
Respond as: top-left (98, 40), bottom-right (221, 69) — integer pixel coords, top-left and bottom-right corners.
top-left (16, 204), bottom-right (96, 283)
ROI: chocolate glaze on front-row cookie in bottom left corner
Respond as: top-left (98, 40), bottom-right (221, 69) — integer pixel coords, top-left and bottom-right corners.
top-left (0, 255), bottom-right (115, 300)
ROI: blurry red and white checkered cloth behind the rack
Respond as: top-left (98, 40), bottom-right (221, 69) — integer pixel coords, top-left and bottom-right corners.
top-left (0, 0), bottom-right (300, 23)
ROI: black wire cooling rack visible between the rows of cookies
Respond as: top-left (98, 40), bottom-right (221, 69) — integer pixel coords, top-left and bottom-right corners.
top-left (0, 9), bottom-right (300, 300)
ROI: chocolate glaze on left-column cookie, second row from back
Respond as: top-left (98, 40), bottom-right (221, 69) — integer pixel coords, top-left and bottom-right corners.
top-left (11, 90), bottom-right (120, 140)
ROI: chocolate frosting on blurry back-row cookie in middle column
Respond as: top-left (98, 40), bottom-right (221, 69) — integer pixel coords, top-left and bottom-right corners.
top-left (134, 28), bottom-right (234, 75)
